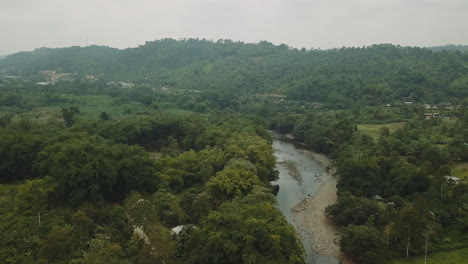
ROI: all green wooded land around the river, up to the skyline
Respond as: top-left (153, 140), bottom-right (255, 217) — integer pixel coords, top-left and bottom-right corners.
top-left (0, 39), bottom-right (468, 263)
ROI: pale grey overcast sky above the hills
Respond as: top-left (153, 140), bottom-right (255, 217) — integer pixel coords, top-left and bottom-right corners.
top-left (0, 0), bottom-right (468, 55)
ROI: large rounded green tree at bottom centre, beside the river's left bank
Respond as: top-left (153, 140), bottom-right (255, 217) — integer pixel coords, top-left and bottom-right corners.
top-left (187, 189), bottom-right (304, 264)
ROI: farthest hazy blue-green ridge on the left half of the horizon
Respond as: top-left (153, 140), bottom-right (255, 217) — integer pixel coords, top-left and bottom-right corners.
top-left (0, 39), bottom-right (288, 74)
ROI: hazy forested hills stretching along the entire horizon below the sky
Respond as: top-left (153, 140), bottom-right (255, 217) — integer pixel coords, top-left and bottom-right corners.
top-left (0, 39), bottom-right (468, 105)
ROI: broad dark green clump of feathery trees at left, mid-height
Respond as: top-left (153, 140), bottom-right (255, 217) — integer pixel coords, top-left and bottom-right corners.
top-left (36, 138), bottom-right (158, 204)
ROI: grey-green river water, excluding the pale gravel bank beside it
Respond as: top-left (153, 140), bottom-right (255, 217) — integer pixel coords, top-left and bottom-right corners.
top-left (273, 135), bottom-right (339, 264)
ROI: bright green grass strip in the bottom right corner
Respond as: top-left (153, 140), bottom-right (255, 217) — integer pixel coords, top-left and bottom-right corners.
top-left (388, 248), bottom-right (468, 264)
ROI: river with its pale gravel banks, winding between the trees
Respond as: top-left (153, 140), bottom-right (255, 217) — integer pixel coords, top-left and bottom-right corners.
top-left (273, 135), bottom-right (339, 264)
